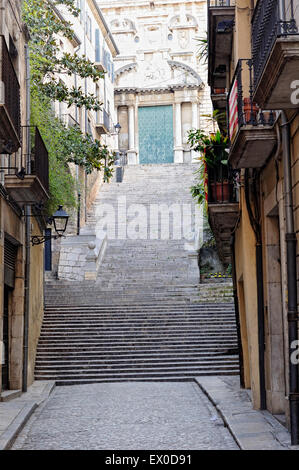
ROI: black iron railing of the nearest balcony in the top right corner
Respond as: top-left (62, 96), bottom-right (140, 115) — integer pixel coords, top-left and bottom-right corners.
top-left (251, 0), bottom-right (299, 88)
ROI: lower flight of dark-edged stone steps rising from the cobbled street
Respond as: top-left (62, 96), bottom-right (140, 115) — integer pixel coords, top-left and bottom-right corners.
top-left (36, 303), bottom-right (238, 385)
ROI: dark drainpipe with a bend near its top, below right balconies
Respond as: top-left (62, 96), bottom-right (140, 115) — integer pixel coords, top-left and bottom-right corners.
top-left (245, 169), bottom-right (267, 410)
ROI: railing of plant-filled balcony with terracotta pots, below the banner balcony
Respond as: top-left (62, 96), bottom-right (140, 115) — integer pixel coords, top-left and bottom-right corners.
top-left (208, 163), bottom-right (239, 204)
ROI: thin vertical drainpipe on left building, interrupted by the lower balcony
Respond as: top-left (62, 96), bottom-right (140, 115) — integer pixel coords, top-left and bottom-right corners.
top-left (22, 43), bottom-right (31, 392)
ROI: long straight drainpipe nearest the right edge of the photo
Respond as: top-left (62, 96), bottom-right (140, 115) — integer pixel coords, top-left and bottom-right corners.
top-left (281, 111), bottom-right (299, 445)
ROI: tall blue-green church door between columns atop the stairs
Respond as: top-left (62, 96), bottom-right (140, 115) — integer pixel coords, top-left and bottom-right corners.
top-left (138, 106), bottom-right (173, 164)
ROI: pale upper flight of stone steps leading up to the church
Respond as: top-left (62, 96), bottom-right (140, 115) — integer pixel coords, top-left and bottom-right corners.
top-left (52, 164), bottom-right (202, 304)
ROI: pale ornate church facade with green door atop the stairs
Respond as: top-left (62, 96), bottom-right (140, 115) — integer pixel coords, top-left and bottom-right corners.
top-left (99, 0), bottom-right (211, 164)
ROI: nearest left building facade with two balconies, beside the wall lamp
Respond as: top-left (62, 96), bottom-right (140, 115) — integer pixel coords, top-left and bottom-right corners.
top-left (0, 0), bottom-right (49, 397)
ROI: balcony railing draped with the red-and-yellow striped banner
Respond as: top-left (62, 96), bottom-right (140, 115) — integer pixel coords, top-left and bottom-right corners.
top-left (227, 59), bottom-right (275, 142)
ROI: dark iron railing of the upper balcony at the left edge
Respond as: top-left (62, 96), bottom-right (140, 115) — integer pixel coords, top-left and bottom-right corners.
top-left (0, 36), bottom-right (21, 143)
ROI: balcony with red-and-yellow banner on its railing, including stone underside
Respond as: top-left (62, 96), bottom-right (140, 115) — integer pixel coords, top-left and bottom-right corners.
top-left (228, 59), bottom-right (277, 169)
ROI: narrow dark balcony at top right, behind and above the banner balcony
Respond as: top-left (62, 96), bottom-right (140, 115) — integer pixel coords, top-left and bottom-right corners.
top-left (208, 0), bottom-right (235, 93)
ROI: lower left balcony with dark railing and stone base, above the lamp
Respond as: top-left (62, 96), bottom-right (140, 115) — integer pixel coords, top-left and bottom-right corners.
top-left (2, 126), bottom-right (49, 205)
